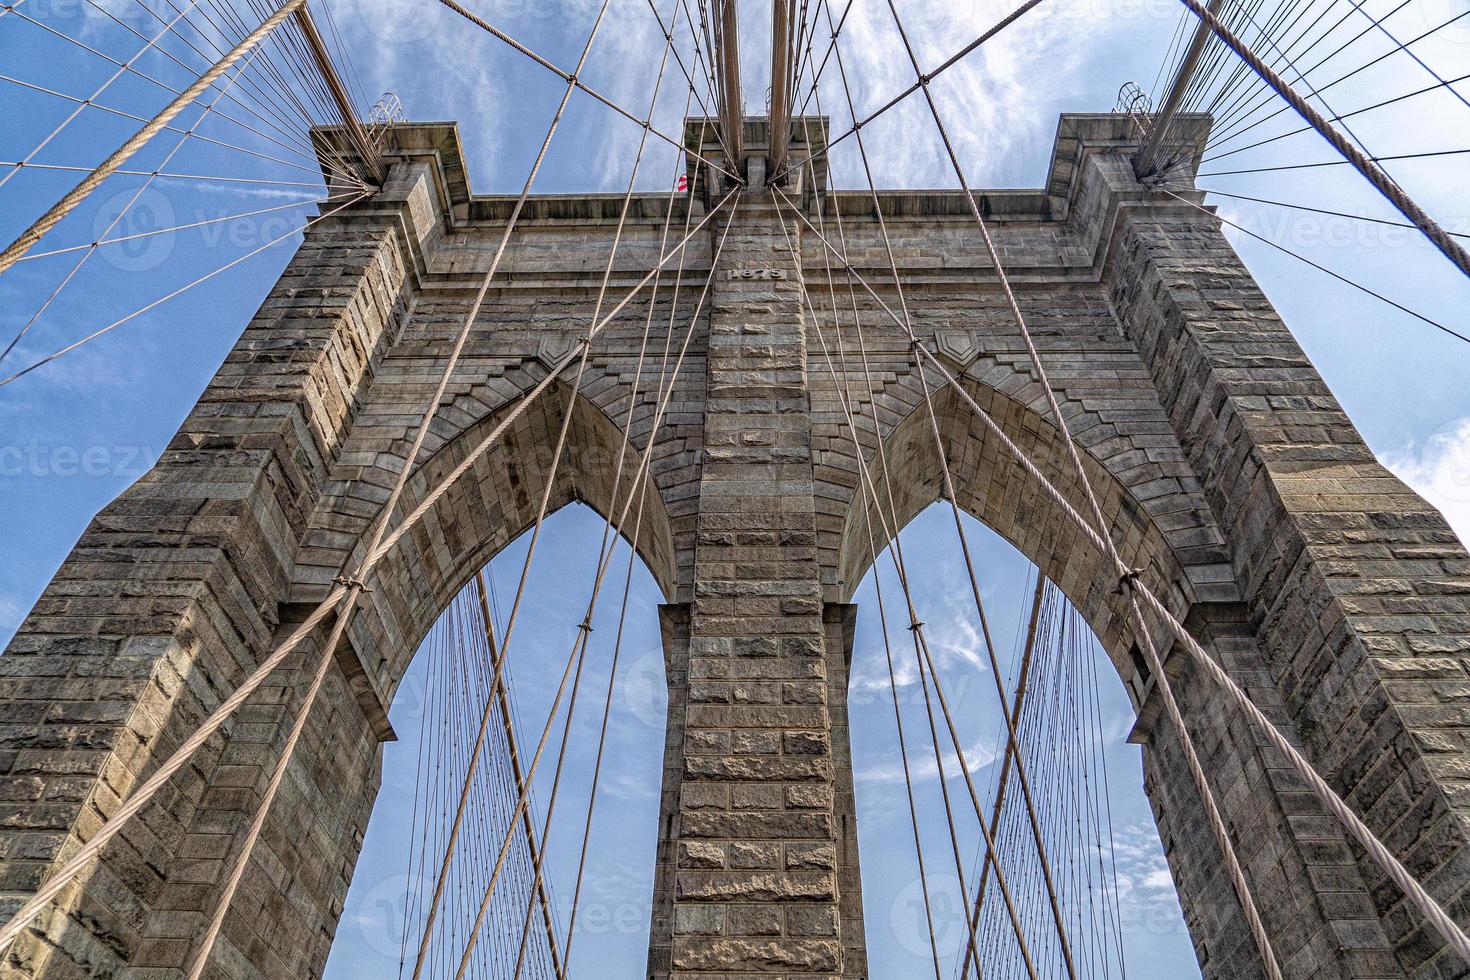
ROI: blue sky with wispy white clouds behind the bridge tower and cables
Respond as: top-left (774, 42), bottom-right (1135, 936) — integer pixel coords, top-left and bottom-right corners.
top-left (0, 0), bottom-right (1470, 977)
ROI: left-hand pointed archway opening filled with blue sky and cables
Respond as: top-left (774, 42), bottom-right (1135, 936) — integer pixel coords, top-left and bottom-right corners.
top-left (325, 505), bottom-right (667, 979)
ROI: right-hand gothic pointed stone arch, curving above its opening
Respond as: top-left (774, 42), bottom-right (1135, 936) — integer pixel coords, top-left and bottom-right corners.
top-left (838, 370), bottom-right (1238, 701)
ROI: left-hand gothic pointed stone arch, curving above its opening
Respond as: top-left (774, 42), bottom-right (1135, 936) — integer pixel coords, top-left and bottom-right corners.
top-left (297, 372), bottom-right (676, 714)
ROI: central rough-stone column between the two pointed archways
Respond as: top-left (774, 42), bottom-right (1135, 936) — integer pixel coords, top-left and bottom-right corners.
top-left (648, 192), bottom-right (866, 977)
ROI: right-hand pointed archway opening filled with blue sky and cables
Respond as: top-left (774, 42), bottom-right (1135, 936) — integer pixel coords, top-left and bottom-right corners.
top-left (848, 501), bottom-right (1198, 977)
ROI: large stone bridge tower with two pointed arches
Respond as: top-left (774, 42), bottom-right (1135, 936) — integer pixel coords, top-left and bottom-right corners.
top-left (0, 115), bottom-right (1470, 980)
